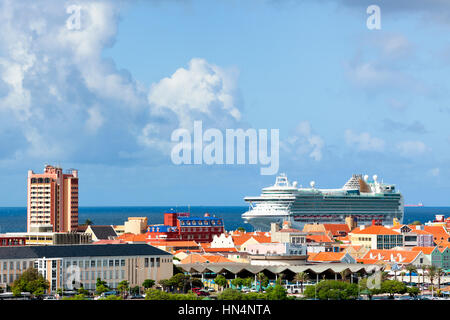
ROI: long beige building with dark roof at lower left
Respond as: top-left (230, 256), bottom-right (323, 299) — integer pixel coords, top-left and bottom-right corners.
top-left (0, 244), bottom-right (173, 292)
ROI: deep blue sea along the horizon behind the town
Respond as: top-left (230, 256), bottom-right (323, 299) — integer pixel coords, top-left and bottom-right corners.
top-left (0, 206), bottom-right (450, 233)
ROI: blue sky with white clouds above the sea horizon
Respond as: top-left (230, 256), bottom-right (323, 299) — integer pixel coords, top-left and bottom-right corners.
top-left (0, 0), bottom-right (450, 206)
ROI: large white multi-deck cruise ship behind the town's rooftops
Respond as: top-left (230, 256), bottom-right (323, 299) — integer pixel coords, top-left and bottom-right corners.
top-left (242, 174), bottom-right (404, 231)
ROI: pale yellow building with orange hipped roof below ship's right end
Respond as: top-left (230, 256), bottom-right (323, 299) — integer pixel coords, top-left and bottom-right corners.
top-left (349, 224), bottom-right (403, 249)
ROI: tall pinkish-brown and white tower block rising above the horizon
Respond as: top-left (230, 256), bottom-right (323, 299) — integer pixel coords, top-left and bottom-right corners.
top-left (27, 165), bottom-right (78, 232)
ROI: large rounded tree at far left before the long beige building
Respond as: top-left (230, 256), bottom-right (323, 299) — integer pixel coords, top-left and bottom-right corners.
top-left (12, 267), bottom-right (50, 296)
